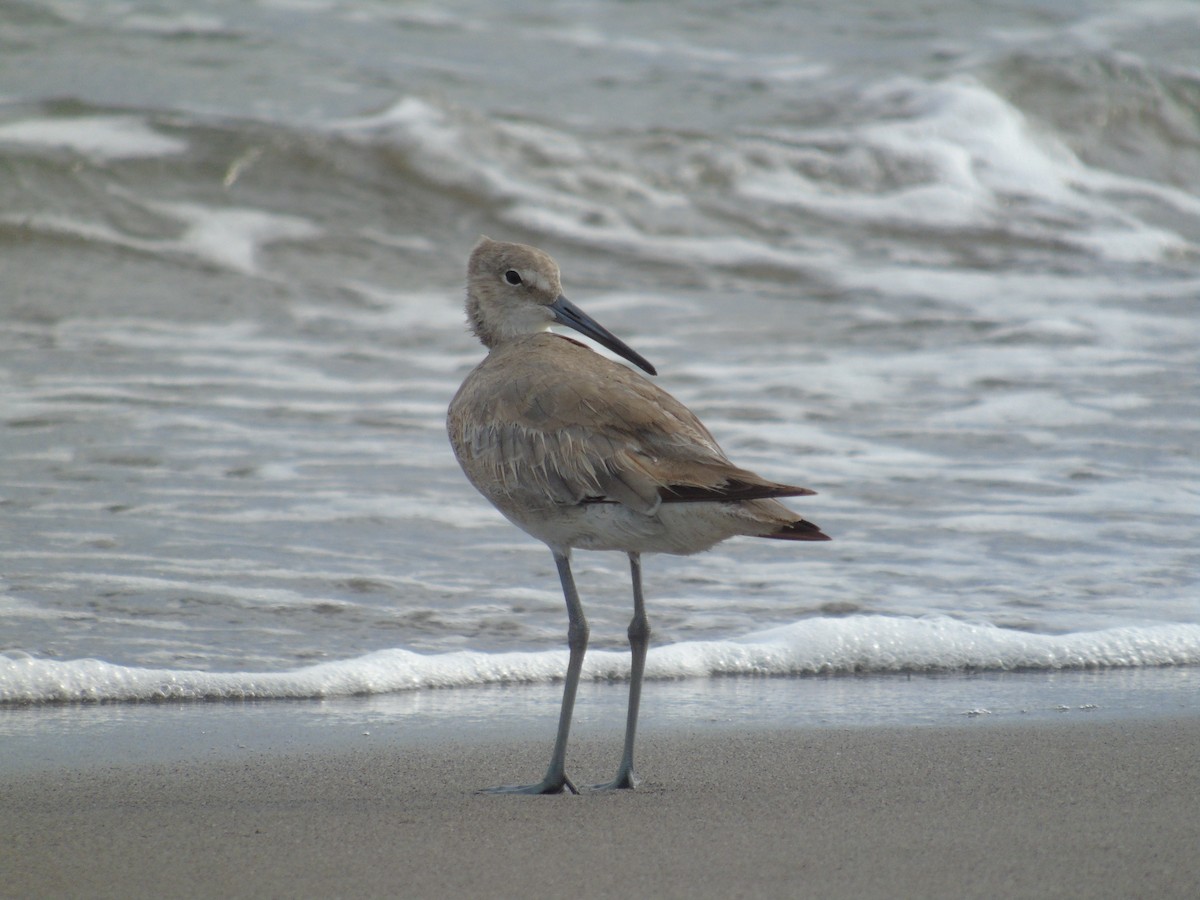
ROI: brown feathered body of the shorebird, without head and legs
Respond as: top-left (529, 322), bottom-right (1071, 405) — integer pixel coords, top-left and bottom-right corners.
top-left (448, 332), bottom-right (824, 552)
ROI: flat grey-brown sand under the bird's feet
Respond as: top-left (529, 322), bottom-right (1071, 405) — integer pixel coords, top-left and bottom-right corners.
top-left (0, 718), bottom-right (1200, 898)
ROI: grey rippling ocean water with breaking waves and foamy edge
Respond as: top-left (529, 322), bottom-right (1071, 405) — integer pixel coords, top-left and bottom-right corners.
top-left (0, 0), bottom-right (1200, 730)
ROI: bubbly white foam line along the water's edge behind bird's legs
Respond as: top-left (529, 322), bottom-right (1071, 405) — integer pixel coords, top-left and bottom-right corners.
top-left (0, 616), bottom-right (1200, 704)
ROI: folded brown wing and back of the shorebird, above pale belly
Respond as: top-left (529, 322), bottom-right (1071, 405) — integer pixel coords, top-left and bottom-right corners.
top-left (450, 335), bottom-right (811, 514)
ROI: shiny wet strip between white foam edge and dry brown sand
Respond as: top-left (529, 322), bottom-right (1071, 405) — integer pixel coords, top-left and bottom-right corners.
top-left (0, 667), bottom-right (1200, 781)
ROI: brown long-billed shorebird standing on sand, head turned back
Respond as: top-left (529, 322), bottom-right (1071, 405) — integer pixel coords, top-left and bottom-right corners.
top-left (446, 238), bottom-right (829, 793)
